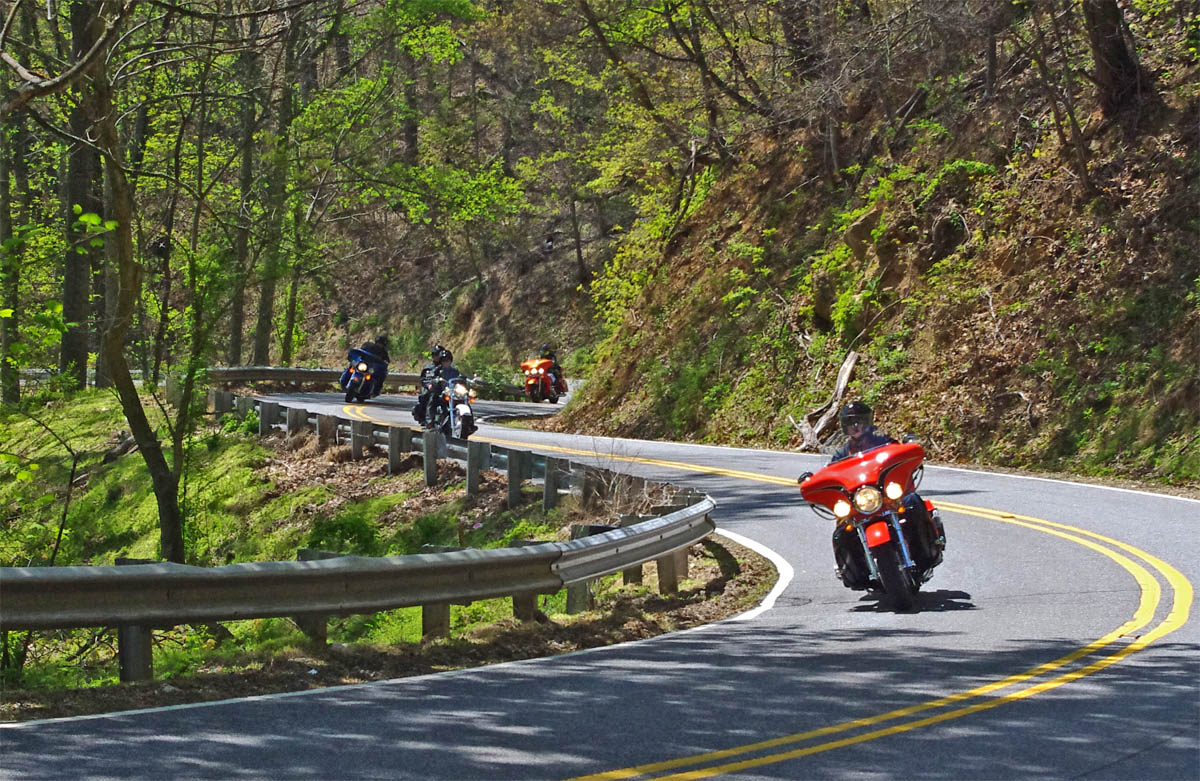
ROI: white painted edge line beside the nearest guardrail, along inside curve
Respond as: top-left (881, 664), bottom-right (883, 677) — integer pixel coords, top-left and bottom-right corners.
top-left (0, 527), bottom-right (794, 731)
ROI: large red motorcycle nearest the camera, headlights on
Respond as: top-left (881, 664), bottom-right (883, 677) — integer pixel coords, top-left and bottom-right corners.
top-left (798, 441), bottom-right (946, 611)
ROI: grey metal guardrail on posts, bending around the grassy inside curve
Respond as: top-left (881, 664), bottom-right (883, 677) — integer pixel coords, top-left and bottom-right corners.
top-left (0, 391), bottom-right (715, 680)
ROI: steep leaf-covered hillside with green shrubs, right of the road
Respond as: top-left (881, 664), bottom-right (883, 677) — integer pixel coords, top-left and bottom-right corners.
top-left (547, 10), bottom-right (1200, 483)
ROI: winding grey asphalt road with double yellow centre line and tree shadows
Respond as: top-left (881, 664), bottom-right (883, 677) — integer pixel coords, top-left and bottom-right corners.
top-left (0, 393), bottom-right (1200, 779)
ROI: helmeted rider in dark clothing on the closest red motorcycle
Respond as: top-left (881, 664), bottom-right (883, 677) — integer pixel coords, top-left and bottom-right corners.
top-left (799, 401), bottom-right (946, 590)
